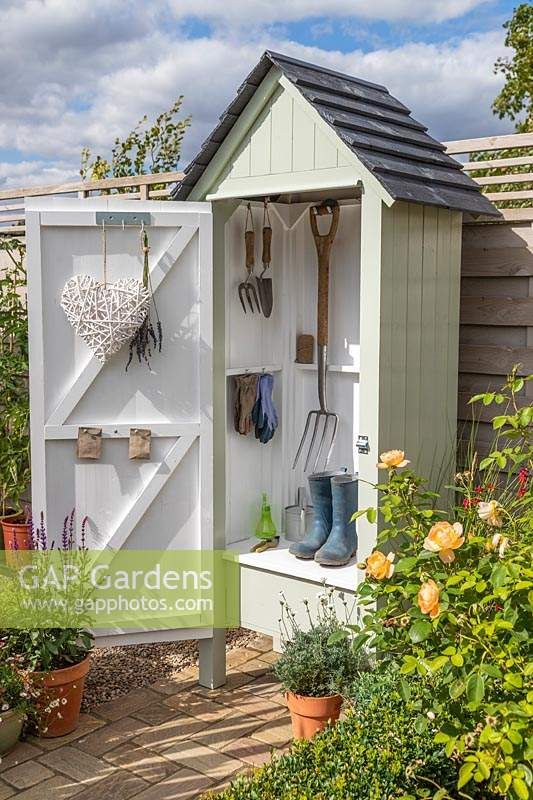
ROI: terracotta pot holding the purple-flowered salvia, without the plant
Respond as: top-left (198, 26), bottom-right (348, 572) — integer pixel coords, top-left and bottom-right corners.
top-left (34, 656), bottom-right (91, 739)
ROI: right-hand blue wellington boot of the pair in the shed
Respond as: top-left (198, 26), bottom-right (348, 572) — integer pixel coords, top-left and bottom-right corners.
top-left (315, 475), bottom-right (357, 567)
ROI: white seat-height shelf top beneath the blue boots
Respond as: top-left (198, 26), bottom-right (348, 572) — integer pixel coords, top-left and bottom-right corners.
top-left (227, 537), bottom-right (361, 592)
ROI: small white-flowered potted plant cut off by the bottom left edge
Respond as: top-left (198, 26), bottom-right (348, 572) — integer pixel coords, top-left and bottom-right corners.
top-left (0, 651), bottom-right (35, 757)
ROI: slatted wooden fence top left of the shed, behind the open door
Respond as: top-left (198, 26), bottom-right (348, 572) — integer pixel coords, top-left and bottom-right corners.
top-left (0, 172), bottom-right (183, 238)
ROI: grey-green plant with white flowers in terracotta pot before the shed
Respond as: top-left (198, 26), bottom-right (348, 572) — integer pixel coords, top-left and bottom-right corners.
top-left (274, 590), bottom-right (363, 739)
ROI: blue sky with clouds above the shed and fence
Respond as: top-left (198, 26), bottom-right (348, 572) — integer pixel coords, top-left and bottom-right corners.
top-left (0, 0), bottom-right (518, 189)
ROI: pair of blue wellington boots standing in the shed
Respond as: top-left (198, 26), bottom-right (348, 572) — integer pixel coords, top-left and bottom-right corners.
top-left (289, 471), bottom-right (357, 567)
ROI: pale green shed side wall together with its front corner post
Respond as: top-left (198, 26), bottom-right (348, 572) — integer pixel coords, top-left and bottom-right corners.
top-left (358, 195), bottom-right (462, 559)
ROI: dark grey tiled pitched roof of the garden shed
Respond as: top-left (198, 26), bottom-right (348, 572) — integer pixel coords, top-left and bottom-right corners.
top-left (172, 50), bottom-right (500, 216)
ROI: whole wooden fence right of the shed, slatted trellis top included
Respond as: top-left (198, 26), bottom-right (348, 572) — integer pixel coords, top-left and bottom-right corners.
top-left (447, 134), bottom-right (533, 453)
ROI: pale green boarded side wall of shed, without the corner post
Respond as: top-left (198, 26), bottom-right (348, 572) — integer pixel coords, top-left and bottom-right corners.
top-left (379, 202), bottom-right (462, 485)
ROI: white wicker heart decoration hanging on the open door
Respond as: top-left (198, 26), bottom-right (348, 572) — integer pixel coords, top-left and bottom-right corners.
top-left (61, 275), bottom-right (150, 362)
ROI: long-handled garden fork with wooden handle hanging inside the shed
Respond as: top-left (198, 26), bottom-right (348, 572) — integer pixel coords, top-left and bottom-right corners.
top-left (292, 200), bottom-right (340, 472)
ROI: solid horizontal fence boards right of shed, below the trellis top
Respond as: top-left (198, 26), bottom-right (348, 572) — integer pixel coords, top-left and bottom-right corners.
top-left (458, 217), bottom-right (533, 453)
